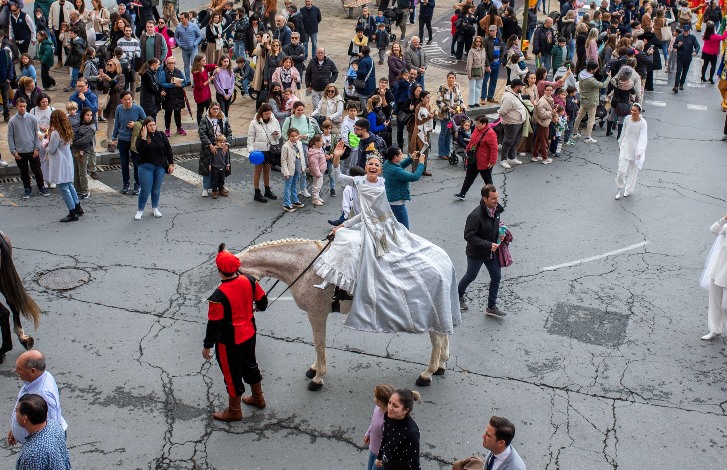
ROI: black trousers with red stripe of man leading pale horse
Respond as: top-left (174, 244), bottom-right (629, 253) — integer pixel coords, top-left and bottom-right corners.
top-left (215, 335), bottom-right (263, 397)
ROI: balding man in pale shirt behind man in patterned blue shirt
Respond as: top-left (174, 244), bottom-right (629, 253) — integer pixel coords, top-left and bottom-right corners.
top-left (8, 349), bottom-right (68, 445)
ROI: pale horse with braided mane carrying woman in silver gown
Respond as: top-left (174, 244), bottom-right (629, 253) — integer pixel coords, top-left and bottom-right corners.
top-left (237, 239), bottom-right (449, 391)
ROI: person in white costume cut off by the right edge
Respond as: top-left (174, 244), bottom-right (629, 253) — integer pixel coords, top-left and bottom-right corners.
top-left (700, 215), bottom-right (727, 341)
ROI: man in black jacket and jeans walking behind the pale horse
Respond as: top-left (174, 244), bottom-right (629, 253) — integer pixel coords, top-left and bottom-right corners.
top-left (457, 184), bottom-right (505, 318)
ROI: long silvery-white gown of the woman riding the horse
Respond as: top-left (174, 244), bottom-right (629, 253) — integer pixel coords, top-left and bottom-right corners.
top-left (313, 168), bottom-right (462, 334)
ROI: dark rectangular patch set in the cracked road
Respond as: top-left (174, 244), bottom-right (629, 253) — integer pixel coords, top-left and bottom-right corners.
top-left (546, 302), bottom-right (629, 347)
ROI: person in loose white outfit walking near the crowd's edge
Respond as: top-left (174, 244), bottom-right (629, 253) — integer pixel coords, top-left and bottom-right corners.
top-left (616, 103), bottom-right (646, 199)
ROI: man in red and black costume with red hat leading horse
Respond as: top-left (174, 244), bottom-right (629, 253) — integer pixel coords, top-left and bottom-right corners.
top-left (202, 243), bottom-right (268, 421)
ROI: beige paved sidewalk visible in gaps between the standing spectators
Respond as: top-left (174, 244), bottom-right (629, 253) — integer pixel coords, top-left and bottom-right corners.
top-left (0, 0), bottom-right (524, 176)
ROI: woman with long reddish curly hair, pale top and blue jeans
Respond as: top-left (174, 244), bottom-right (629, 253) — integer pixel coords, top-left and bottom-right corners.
top-left (41, 109), bottom-right (83, 222)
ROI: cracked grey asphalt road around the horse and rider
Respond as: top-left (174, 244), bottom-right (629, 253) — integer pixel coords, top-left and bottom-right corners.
top-left (0, 26), bottom-right (727, 470)
